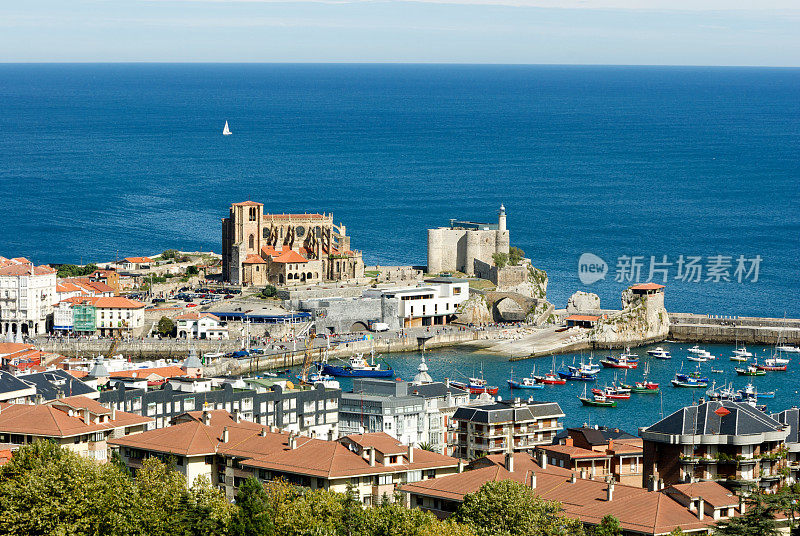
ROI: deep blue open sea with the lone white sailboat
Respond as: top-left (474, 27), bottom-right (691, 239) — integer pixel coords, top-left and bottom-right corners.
top-left (0, 64), bottom-right (800, 317)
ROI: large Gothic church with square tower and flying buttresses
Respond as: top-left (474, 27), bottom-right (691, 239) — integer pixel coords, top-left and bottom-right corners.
top-left (222, 201), bottom-right (364, 286)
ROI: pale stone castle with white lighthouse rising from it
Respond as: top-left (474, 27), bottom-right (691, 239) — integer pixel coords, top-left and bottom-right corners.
top-left (428, 205), bottom-right (510, 275)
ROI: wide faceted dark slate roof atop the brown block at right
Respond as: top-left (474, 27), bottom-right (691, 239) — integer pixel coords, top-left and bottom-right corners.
top-left (642, 400), bottom-right (783, 436)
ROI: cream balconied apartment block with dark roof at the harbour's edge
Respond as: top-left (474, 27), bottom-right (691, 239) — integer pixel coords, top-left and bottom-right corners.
top-left (453, 398), bottom-right (564, 460)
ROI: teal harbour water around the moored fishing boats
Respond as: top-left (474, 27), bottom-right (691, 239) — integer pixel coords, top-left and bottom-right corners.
top-left (318, 343), bottom-right (800, 435)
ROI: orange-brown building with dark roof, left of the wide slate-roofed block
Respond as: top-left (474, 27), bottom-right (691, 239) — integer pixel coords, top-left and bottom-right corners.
top-left (536, 426), bottom-right (644, 487)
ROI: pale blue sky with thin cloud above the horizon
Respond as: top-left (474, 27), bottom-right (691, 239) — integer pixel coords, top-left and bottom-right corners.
top-left (0, 0), bottom-right (800, 65)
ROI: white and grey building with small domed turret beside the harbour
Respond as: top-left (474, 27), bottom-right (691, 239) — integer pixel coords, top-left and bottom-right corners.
top-left (339, 370), bottom-right (469, 453)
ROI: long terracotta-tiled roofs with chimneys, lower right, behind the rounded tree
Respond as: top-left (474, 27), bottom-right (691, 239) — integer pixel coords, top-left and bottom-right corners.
top-left (400, 453), bottom-right (752, 536)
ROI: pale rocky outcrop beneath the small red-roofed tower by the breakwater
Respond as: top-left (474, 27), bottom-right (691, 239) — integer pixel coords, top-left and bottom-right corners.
top-left (590, 289), bottom-right (669, 346)
